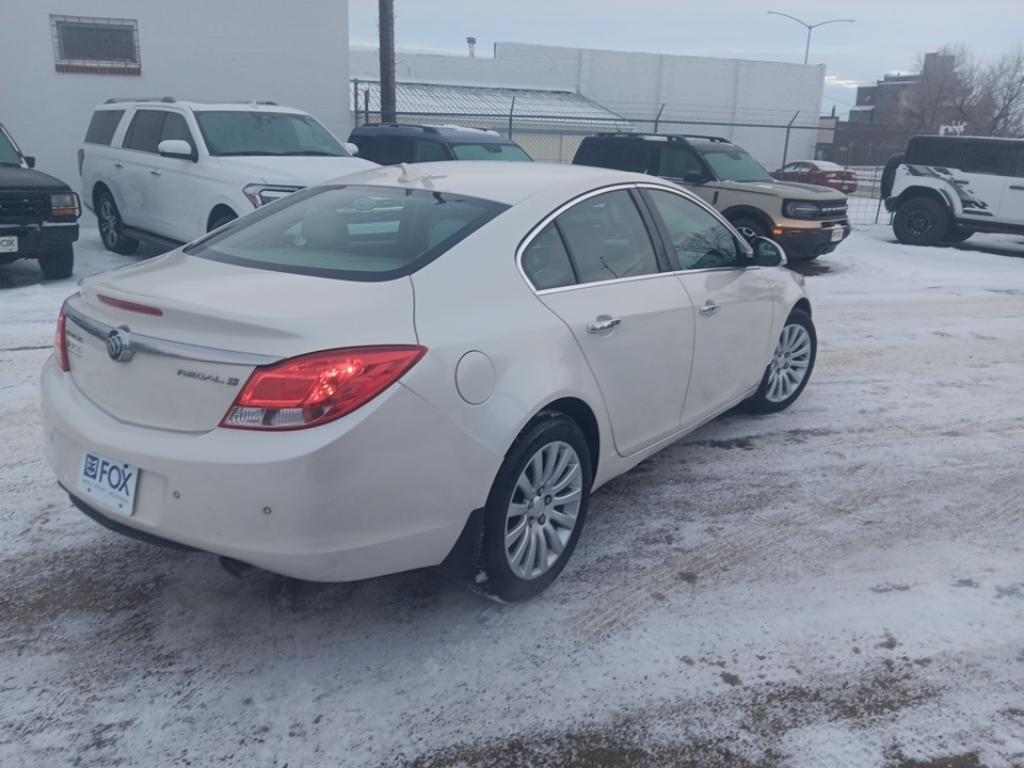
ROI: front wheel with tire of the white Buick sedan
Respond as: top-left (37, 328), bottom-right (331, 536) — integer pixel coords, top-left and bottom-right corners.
top-left (740, 309), bottom-right (818, 414)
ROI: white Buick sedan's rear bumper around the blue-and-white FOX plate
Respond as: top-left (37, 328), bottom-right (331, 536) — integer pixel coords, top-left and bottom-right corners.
top-left (41, 359), bottom-right (501, 582)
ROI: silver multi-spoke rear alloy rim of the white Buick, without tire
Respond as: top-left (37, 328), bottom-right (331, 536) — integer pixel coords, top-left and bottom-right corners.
top-left (505, 441), bottom-right (584, 580)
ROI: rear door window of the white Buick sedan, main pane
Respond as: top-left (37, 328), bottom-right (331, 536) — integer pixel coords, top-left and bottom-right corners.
top-left (556, 189), bottom-right (659, 283)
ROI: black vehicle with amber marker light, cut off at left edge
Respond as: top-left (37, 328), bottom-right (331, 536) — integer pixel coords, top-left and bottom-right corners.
top-left (0, 123), bottom-right (81, 280)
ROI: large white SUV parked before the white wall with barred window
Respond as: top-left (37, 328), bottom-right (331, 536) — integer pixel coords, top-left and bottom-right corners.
top-left (78, 96), bottom-right (377, 253)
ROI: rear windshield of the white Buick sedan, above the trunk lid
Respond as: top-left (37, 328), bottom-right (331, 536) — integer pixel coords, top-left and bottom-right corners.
top-left (185, 186), bottom-right (508, 281)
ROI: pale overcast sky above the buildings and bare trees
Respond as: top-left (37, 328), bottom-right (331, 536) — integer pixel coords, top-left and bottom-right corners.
top-left (349, 0), bottom-right (1024, 118)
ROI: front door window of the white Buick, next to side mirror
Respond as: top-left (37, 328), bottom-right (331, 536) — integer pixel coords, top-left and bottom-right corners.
top-left (645, 189), bottom-right (739, 269)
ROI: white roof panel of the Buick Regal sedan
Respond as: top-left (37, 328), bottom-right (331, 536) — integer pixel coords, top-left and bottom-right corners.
top-left (329, 160), bottom-right (672, 205)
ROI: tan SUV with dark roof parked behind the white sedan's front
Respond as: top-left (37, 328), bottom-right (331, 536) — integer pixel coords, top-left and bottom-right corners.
top-left (572, 133), bottom-right (850, 261)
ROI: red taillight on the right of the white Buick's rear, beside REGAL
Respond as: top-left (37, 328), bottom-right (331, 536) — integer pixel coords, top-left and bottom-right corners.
top-left (220, 346), bottom-right (427, 430)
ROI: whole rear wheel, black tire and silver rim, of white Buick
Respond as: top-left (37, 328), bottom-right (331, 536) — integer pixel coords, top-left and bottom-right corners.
top-left (473, 412), bottom-right (593, 602)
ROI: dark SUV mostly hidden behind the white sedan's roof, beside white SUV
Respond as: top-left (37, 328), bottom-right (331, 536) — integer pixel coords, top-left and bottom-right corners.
top-left (348, 123), bottom-right (531, 165)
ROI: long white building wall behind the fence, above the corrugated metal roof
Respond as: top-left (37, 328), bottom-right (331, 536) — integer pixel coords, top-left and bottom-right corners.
top-left (350, 43), bottom-right (825, 169)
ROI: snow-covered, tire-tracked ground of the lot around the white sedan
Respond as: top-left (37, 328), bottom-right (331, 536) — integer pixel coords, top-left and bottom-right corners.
top-left (0, 227), bottom-right (1024, 768)
